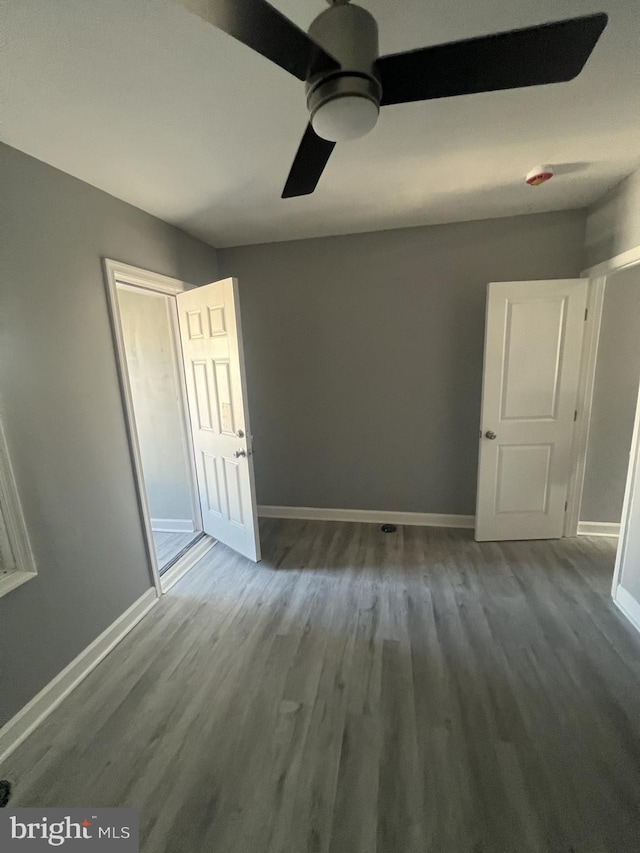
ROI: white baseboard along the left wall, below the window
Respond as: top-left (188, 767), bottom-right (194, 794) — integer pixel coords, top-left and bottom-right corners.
top-left (0, 588), bottom-right (159, 763)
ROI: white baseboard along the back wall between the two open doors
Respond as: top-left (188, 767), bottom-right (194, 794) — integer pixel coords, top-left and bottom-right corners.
top-left (258, 506), bottom-right (476, 528)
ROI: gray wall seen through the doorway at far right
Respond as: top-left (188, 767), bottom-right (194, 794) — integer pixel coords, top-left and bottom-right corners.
top-left (580, 267), bottom-right (640, 523)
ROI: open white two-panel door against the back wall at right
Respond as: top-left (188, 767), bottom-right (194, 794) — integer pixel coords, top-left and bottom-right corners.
top-left (476, 279), bottom-right (587, 541)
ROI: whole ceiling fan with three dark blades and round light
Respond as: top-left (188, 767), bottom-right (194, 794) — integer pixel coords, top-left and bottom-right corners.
top-left (181, 0), bottom-right (607, 198)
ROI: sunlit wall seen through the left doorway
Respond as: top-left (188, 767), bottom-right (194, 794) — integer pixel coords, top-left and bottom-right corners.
top-left (118, 288), bottom-right (193, 529)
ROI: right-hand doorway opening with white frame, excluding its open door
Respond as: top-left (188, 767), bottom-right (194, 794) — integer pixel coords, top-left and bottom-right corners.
top-left (567, 247), bottom-right (640, 631)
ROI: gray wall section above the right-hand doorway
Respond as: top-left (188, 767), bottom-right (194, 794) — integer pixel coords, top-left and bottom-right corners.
top-left (585, 169), bottom-right (640, 267)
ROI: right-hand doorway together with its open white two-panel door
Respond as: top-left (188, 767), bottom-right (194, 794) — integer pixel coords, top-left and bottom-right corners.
top-left (476, 253), bottom-right (640, 630)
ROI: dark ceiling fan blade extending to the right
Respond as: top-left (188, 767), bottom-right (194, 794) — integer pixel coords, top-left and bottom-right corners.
top-left (376, 13), bottom-right (607, 105)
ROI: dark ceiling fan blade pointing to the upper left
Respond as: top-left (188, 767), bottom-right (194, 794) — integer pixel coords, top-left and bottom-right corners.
top-left (180, 0), bottom-right (340, 80)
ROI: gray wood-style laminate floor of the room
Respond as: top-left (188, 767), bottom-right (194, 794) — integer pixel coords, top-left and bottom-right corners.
top-left (0, 520), bottom-right (640, 853)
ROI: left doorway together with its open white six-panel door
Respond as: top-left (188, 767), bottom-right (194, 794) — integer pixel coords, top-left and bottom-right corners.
top-left (104, 259), bottom-right (260, 594)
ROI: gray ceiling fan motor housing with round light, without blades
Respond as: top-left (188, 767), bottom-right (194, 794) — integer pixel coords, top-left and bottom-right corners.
top-left (306, 4), bottom-right (382, 138)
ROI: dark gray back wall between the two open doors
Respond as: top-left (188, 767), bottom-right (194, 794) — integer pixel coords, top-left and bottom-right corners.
top-left (219, 211), bottom-right (584, 514)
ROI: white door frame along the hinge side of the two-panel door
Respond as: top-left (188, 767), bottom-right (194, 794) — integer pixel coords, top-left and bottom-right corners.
top-left (564, 246), bottom-right (640, 536)
